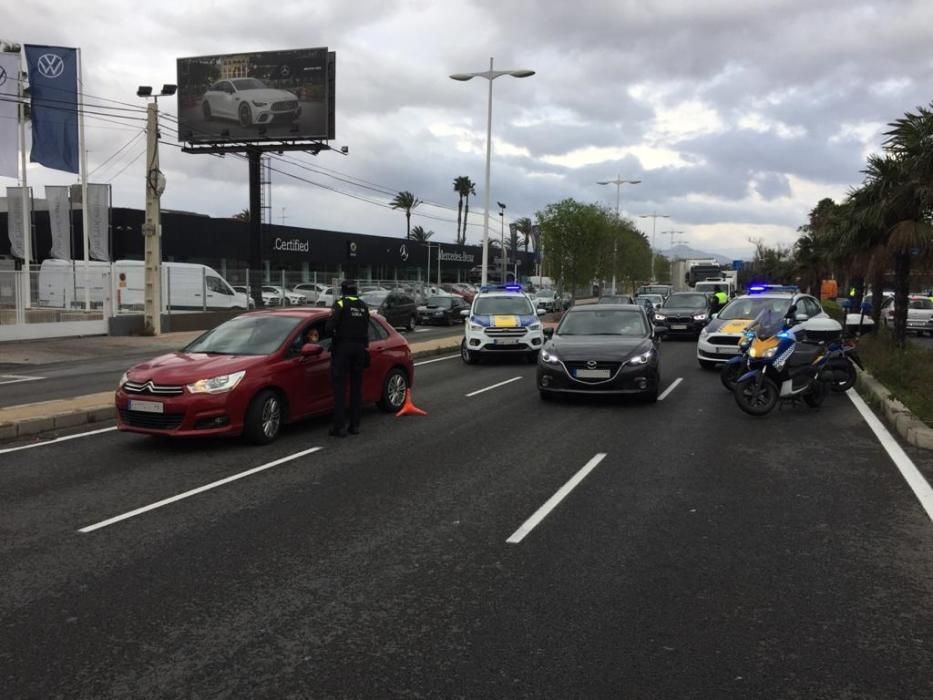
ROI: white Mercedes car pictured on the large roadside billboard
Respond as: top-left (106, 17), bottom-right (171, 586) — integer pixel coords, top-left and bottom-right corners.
top-left (201, 78), bottom-right (301, 127)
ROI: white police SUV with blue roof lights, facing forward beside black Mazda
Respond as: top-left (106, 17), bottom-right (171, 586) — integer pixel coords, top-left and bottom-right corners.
top-left (460, 284), bottom-right (544, 365)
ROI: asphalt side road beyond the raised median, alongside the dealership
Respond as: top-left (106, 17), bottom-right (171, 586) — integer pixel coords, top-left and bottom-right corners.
top-left (0, 326), bottom-right (463, 407)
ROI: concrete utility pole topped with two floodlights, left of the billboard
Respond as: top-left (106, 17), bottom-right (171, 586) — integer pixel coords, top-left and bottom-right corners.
top-left (136, 84), bottom-right (177, 335)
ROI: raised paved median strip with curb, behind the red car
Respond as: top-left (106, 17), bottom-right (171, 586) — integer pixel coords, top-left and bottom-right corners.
top-left (0, 336), bottom-right (460, 443)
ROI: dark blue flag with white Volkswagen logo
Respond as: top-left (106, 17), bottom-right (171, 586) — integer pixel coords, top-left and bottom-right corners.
top-left (25, 44), bottom-right (79, 173)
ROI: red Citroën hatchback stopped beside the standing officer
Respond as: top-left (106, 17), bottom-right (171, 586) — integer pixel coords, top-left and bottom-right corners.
top-left (116, 308), bottom-right (414, 444)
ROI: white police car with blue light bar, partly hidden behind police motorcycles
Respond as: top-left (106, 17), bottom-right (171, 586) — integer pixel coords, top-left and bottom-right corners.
top-left (697, 285), bottom-right (829, 369)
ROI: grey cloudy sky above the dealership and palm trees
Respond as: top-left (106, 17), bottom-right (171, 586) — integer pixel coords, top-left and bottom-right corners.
top-left (0, 0), bottom-right (933, 256)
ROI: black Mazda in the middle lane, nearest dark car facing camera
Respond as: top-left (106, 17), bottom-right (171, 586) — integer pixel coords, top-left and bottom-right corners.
top-left (538, 304), bottom-right (665, 401)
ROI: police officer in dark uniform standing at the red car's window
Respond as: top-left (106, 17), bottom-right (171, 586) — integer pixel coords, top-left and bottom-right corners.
top-left (325, 280), bottom-right (369, 437)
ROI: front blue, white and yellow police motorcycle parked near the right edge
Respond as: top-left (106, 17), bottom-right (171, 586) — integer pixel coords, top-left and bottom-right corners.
top-left (733, 306), bottom-right (842, 416)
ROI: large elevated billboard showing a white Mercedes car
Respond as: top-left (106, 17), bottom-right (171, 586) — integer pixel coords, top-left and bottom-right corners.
top-left (178, 47), bottom-right (336, 144)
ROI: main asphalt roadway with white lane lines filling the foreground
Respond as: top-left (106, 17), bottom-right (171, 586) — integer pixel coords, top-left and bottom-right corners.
top-left (0, 341), bottom-right (933, 698)
